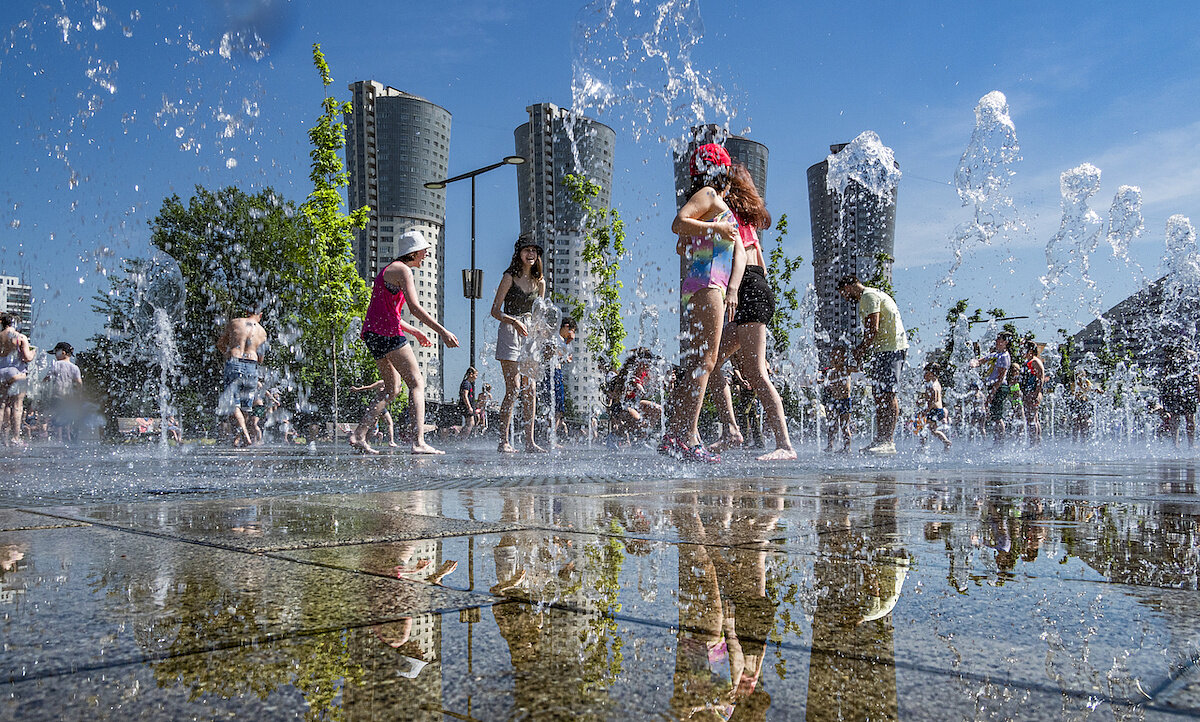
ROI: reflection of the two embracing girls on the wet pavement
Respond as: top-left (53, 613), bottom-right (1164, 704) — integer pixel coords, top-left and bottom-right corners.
top-left (671, 486), bottom-right (782, 720)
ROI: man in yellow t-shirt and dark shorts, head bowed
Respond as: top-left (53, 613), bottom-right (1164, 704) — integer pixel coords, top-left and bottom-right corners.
top-left (838, 273), bottom-right (908, 455)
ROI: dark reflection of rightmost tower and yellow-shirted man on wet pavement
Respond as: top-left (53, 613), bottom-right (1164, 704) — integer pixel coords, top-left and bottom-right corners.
top-left (806, 479), bottom-right (908, 720)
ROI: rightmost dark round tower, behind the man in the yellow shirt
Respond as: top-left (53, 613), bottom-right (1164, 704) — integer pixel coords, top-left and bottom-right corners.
top-left (808, 143), bottom-right (899, 362)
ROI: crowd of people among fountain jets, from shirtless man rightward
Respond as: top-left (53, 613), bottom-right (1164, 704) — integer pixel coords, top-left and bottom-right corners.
top-left (196, 144), bottom-right (1200, 463)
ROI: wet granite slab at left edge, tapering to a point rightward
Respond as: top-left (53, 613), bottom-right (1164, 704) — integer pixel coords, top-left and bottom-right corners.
top-left (0, 527), bottom-right (490, 682)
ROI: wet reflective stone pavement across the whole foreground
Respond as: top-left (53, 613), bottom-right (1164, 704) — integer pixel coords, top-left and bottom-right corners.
top-left (0, 447), bottom-right (1200, 720)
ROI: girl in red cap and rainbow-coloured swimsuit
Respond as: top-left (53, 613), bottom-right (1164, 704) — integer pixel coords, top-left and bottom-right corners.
top-left (659, 143), bottom-right (745, 463)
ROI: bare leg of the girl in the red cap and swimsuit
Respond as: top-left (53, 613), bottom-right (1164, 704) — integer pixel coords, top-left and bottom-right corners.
top-left (667, 288), bottom-right (725, 446)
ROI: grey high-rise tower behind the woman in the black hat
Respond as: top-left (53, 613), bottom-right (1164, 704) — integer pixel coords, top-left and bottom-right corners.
top-left (512, 103), bottom-right (617, 411)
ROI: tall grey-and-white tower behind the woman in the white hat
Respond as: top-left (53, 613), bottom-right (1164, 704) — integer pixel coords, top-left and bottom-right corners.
top-left (346, 80), bottom-right (450, 401)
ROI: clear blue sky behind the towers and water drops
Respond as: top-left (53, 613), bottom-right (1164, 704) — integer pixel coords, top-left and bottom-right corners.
top-left (0, 0), bottom-right (1200, 393)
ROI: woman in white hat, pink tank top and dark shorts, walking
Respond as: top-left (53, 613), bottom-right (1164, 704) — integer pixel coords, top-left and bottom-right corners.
top-left (349, 230), bottom-right (458, 453)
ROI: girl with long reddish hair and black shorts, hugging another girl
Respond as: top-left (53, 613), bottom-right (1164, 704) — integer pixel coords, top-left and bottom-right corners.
top-left (712, 163), bottom-right (796, 462)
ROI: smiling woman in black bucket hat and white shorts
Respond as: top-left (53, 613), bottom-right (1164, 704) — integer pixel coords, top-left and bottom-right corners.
top-left (492, 234), bottom-right (546, 453)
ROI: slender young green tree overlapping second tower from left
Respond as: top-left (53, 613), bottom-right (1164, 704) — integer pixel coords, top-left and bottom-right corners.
top-left (563, 174), bottom-right (625, 367)
